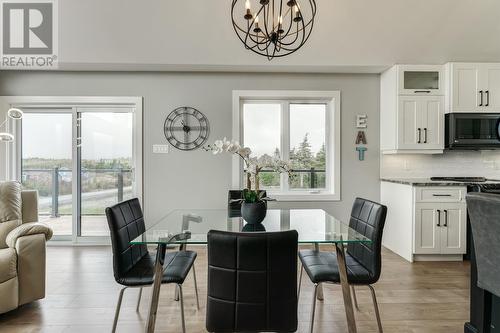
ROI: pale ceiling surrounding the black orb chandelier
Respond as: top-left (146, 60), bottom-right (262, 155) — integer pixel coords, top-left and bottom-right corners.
top-left (54, 0), bottom-right (500, 72)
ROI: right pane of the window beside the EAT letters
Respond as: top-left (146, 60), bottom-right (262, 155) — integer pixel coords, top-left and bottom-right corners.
top-left (290, 104), bottom-right (326, 189)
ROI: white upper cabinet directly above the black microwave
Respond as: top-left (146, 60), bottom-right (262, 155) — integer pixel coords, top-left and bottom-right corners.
top-left (446, 63), bottom-right (500, 112)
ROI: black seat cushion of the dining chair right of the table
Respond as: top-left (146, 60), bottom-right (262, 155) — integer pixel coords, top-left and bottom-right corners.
top-left (299, 250), bottom-right (376, 284)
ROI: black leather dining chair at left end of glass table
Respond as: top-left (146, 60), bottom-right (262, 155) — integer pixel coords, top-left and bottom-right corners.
top-left (106, 198), bottom-right (199, 332)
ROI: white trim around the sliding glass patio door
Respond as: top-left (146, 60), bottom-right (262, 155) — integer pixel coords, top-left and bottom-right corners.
top-left (0, 96), bottom-right (145, 245)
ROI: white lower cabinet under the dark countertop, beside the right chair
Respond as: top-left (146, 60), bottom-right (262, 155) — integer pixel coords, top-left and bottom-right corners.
top-left (380, 181), bottom-right (467, 262)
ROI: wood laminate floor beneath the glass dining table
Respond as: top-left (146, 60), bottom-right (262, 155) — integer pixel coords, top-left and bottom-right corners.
top-left (0, 247), bottom-right (469, 333)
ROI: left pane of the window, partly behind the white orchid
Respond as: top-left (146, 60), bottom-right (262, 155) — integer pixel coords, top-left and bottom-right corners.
top-left (243, 103), bottom-right (281, 189)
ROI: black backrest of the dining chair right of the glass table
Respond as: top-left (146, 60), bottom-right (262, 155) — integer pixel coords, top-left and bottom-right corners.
top-left (347, 198), bottom-right (387, 284)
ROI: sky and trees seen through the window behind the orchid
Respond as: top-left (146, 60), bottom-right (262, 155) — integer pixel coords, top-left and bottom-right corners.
top-left (243, 102), bottom-right (327, 190)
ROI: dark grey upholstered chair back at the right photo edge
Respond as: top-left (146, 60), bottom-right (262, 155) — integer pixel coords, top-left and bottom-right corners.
top-left (467, 193), bottom-right (500, 296)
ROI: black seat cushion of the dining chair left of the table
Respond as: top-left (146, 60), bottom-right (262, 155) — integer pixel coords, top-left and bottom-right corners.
top-left (117, 251), bottom-right (196, 286)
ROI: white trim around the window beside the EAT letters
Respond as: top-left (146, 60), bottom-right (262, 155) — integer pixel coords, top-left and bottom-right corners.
top-left (232, 90), bottom-right (341, 201)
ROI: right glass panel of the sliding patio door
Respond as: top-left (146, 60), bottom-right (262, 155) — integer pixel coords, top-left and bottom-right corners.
top-left (80, 112), bottom-right (133, 236)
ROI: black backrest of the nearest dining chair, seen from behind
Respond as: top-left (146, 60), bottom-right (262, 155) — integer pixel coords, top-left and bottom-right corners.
top-left (206, 230), bottom-right (298, 332)
